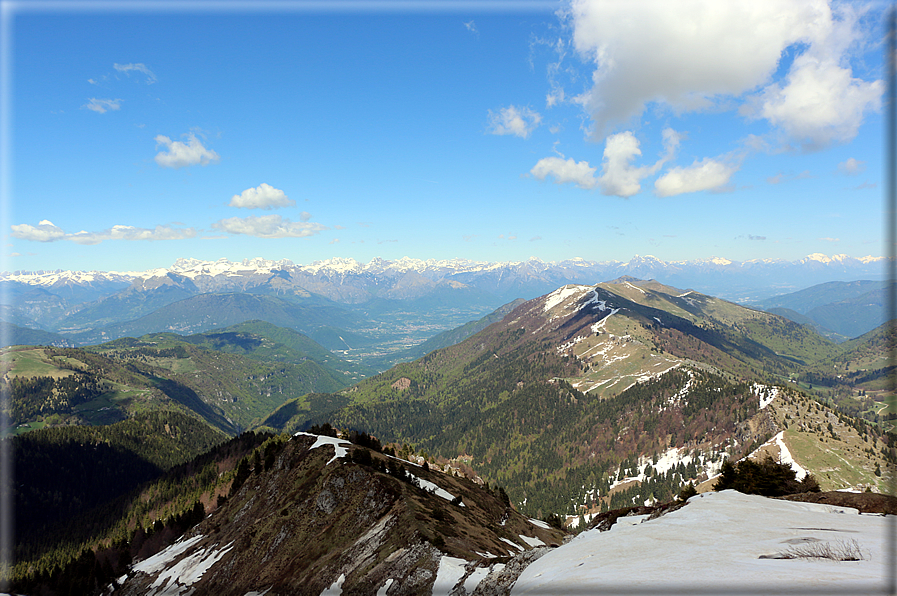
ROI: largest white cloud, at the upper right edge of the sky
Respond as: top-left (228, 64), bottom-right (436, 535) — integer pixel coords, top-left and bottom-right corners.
top-left (567, 0), bottom-right (883, 150)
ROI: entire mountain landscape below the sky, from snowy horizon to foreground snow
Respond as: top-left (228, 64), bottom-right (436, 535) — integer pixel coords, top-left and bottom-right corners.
top-left (0, 255), bottom-right (897, 596)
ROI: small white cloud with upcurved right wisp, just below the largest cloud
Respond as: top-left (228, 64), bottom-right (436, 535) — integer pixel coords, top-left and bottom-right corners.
top-left (530, 128), bottom-right (682, 197)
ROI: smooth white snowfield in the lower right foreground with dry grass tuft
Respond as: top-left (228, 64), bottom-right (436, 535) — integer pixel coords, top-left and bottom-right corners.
top-left (511, 490), bottom-right (895, 596)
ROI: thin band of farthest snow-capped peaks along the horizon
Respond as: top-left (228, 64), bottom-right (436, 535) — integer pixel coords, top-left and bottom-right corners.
top-left (0, 253), bottom-right (884, 302)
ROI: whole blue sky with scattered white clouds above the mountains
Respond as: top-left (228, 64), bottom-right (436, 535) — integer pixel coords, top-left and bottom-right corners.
top-left (3, 0), bottom-right (884, 271)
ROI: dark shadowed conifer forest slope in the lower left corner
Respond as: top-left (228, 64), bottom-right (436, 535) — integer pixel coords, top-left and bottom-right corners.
top-left (4, 426), bottom-right (271, 596)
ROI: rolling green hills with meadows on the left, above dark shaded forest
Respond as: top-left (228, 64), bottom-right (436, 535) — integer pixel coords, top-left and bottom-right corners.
top-left (0, 322), bottom-right (367, 435)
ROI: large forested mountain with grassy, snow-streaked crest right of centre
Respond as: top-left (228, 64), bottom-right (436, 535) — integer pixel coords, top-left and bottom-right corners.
top-left (263, 280), bottom-right (848, 516)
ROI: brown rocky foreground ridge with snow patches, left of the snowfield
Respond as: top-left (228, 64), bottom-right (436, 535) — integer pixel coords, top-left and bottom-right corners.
top-left (98, 434), bottom-right (563, 595)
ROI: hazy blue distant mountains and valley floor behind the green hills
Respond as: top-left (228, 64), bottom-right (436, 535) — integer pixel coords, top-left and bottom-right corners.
top-left (0, 254), bottom-right (883, 370)
